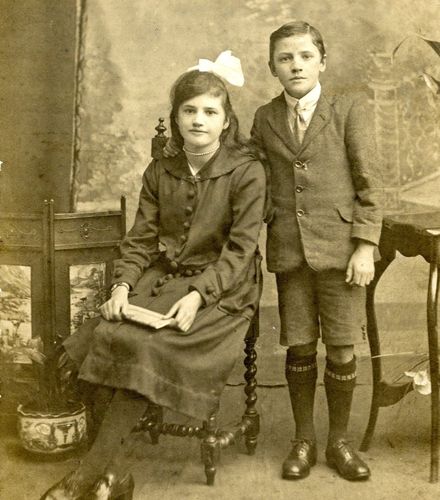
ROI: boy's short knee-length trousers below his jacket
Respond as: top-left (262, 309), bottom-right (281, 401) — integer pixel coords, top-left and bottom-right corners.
top-left (276, 264), bottom-right (367, 346)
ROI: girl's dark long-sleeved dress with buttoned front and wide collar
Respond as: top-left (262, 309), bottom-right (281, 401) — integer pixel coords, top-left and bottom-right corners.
top-left (64, 146), bottom-right (265, 419)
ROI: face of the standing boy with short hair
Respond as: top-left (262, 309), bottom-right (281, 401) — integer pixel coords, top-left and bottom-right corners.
top-left (269, 33), bottom-right (326, 99)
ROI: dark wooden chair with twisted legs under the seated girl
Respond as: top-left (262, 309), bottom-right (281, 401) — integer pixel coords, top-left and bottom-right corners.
top-left (132, 118), bottom-right (260, 486)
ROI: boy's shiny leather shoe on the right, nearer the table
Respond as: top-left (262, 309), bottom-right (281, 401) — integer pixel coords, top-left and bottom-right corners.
top-left (325, 439), bottom-right (370, 481)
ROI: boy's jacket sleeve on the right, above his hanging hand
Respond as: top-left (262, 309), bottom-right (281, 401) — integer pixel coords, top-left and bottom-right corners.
top-left (345, 96), bottom-right (384, 245)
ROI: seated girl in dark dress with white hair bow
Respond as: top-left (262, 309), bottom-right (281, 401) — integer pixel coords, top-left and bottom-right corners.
top-left (42, 53), bottom-right (265, 500)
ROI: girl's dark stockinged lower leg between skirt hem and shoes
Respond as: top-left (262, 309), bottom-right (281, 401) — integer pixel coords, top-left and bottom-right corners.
top-left (80, 390), bottom-right (148, 482)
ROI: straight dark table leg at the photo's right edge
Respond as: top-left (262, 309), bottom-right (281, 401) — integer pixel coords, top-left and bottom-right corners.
top-left (427, 259), bottom-right (440, 483)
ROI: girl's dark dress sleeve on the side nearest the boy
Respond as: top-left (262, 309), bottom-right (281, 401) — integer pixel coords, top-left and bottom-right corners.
top-left (190, 161), bottom-right (266, 305)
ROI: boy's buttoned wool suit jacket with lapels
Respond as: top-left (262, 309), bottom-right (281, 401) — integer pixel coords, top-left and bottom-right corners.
top-left (251, 88), bottom-right (383, 273)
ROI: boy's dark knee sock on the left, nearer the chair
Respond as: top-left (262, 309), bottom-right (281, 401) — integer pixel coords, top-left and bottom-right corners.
top-left (286, 351), bottom-right (318, 440)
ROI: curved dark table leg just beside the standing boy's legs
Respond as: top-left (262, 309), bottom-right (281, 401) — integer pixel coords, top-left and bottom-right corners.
top-left (359, 252), bottom-right (395, 451)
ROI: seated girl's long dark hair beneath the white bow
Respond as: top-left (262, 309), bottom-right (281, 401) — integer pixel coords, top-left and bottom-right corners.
top-left (170, 70), bottom-right (247, 150)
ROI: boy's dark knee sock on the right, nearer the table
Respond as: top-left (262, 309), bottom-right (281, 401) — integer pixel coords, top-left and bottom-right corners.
top-left (324, 357), bottom-right (356, 444)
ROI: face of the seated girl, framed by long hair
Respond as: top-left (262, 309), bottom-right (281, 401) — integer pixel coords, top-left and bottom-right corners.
top-left (176, 94), bottom-right (229, 153)
